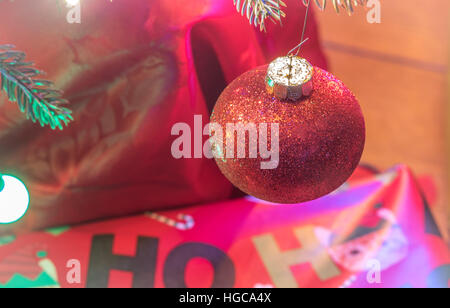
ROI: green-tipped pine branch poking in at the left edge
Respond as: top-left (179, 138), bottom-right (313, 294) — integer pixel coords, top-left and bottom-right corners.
top-left (0, 45), bottom-right (73, 130)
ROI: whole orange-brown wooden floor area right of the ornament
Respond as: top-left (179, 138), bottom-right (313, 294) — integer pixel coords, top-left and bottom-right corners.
top-left (316, 0), bottom-right (450, 236)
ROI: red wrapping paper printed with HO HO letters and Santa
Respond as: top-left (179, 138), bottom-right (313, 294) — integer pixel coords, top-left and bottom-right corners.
top-left (0, 166), bottom-right (450, 288)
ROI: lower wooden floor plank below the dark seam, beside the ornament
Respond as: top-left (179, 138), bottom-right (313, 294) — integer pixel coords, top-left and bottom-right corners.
top-left (327, 50), bottom-right (448, 237)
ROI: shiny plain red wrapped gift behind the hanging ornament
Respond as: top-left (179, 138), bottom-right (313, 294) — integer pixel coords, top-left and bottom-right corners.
top-left (0, 0), bottom-right (326, 233)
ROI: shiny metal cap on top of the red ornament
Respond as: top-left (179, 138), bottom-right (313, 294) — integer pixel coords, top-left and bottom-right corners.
top-left (266, 55), bottom-right (314, 101)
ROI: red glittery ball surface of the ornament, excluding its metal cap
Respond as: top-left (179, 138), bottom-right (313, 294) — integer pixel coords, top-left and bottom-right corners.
top-left (211, 66), bottom-right (365, 203)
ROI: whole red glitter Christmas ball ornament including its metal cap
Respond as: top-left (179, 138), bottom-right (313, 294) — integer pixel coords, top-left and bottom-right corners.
top-left (210, 56), bottom-right (365, 203)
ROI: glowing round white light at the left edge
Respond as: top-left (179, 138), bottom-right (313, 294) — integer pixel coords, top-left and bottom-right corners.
top-left (0, 175), bottom-right (30, 224)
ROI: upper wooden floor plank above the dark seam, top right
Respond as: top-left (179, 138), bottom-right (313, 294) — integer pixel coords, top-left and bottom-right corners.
top-left (316, 0), bottom-right (450, 68)
